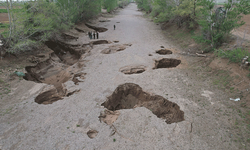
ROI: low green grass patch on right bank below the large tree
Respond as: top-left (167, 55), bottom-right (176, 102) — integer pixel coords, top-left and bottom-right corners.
top-left (215, 48), bottom-right (250, 63)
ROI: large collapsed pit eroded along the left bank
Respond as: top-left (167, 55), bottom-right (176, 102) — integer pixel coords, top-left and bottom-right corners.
top-left (24, 41), bottom-right (88, 104)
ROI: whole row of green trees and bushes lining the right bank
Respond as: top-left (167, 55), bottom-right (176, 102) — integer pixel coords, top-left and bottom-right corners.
top-left (136, 0), bottom-right (250, 48)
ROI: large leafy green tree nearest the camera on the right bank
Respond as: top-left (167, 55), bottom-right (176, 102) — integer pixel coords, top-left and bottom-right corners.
top-left (198, 0), bottom-right (250, 48)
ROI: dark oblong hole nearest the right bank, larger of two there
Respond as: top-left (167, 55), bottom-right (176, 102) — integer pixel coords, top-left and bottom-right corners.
top-left (154, 58), bottom-right (181, 69)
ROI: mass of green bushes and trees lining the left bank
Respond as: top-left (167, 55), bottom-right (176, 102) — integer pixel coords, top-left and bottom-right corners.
top-left (0, 0), bottom-right (130, 53)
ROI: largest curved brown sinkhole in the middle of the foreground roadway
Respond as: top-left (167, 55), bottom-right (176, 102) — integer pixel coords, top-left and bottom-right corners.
top-left (102, 83), bottom-right (184, 124)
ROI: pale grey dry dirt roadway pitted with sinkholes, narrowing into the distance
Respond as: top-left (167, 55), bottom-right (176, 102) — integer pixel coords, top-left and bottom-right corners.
top-left (0, 3), bottom-right (246, 150)
